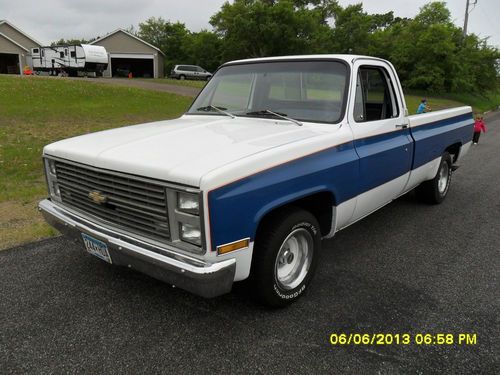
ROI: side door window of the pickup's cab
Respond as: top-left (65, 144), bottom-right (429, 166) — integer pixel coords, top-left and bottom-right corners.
top-left (354, 66), bottom-right (399, 122)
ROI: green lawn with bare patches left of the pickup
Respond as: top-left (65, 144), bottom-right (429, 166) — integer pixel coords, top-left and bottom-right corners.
top-left (0, 75), bottom-right (191, 249)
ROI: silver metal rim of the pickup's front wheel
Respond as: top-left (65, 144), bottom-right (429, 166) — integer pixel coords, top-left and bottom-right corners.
top-left (274, 228), bottom-right (313, 290)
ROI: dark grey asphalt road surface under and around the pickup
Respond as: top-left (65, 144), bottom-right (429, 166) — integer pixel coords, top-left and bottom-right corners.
top-left (0, 116), bottom-right (500, 374)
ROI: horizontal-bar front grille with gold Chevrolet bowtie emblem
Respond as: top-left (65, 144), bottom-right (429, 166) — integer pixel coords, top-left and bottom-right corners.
top-left (55, 161), bottom-right (170, 240)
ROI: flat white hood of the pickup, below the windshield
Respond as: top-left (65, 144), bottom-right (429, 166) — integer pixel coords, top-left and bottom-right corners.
top-left (44, 115), bottom-right (322, 187)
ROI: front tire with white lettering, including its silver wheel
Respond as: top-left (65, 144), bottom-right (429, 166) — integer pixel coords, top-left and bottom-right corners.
top-left (250, 208), bottom-right (321, 307)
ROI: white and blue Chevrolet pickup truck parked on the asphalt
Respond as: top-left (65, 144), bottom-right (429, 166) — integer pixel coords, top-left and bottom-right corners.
top-left (39, 55), bottom-right (473, 306)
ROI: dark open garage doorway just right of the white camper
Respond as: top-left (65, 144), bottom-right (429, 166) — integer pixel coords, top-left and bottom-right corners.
top-left (110, 54), bottom-right (155, 78)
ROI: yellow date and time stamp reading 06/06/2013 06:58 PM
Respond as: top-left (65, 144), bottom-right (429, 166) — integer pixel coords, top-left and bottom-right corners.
top-left (330, 333), bottom-right (477, 346)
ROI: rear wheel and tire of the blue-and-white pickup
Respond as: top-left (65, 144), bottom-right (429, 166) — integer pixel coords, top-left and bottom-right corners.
top-left (416, 152), bottom-right (452, 204)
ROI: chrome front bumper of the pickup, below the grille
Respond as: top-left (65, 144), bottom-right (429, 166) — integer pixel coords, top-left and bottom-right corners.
top-left (38, 199), bottom-right (236, 298)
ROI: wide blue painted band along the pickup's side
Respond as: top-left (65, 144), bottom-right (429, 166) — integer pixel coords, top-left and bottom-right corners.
top-left (208, 114), bottom-right (472, 250)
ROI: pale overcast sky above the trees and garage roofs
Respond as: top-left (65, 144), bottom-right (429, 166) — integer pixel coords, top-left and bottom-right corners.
top-left (0, 0), bottom-right (500, 46)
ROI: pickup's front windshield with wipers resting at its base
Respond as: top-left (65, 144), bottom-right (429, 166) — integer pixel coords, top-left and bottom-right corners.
top-left (187, 61), bottom-right (348, 123)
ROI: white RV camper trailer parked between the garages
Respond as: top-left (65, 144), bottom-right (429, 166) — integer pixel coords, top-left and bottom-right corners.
top-left (31, 44), bottom-right (108, 76)
